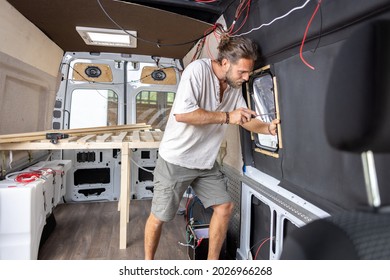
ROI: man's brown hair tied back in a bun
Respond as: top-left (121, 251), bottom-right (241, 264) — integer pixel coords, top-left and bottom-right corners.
top-left (217, 35), bottom-right (258, 64)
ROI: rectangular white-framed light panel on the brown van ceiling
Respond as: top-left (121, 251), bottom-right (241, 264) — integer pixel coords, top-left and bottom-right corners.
top-left (76, 26), bottom-right (137, 48)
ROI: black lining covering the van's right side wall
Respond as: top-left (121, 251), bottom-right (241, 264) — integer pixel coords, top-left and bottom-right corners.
top-left (225, 0), bottom-right (390, 212)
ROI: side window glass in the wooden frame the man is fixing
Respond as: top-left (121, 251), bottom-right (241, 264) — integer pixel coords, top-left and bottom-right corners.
top-left (248, 66), bottom-right (280, 153)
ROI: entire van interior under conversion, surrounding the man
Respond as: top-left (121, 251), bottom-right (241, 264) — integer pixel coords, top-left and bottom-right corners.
top-left (0, 0), bottom-right (390, 260)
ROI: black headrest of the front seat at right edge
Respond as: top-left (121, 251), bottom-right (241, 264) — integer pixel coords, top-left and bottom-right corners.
top-left (325, 21), bottom-right (390, 153)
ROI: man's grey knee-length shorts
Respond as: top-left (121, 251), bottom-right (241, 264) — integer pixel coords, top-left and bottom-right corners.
top-left (151, 156), bottom-right (231, 222)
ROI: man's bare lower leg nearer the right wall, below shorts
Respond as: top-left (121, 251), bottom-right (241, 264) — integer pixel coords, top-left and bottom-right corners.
top-left (207, 202), bottom-right (234, 260)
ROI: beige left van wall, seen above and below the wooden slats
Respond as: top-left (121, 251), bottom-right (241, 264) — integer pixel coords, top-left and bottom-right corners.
top-left (0, 0), bottom-right (63, 175)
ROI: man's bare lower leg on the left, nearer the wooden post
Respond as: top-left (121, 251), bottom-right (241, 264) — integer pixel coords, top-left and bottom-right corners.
top-left (144, 213), bottom-right (164, 260)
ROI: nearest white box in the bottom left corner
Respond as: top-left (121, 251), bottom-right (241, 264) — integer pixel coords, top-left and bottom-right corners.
top-left (0, 179), bottom-right (46, 260)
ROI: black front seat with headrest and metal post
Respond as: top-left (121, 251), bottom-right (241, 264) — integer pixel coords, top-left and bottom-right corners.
top-left (280, 21), bottom-right (390, 260)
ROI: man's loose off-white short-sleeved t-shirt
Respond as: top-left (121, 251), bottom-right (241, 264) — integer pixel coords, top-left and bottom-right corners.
top-left (159, 58), bottom-right (247, 169)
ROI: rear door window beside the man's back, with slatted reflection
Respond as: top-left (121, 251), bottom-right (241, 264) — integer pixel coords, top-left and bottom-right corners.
top-left (136, 90), bottom-right (175, 130)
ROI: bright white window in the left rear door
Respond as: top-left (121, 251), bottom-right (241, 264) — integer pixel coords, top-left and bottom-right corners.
top-left (69, 89), bottom-right (118, 128)
